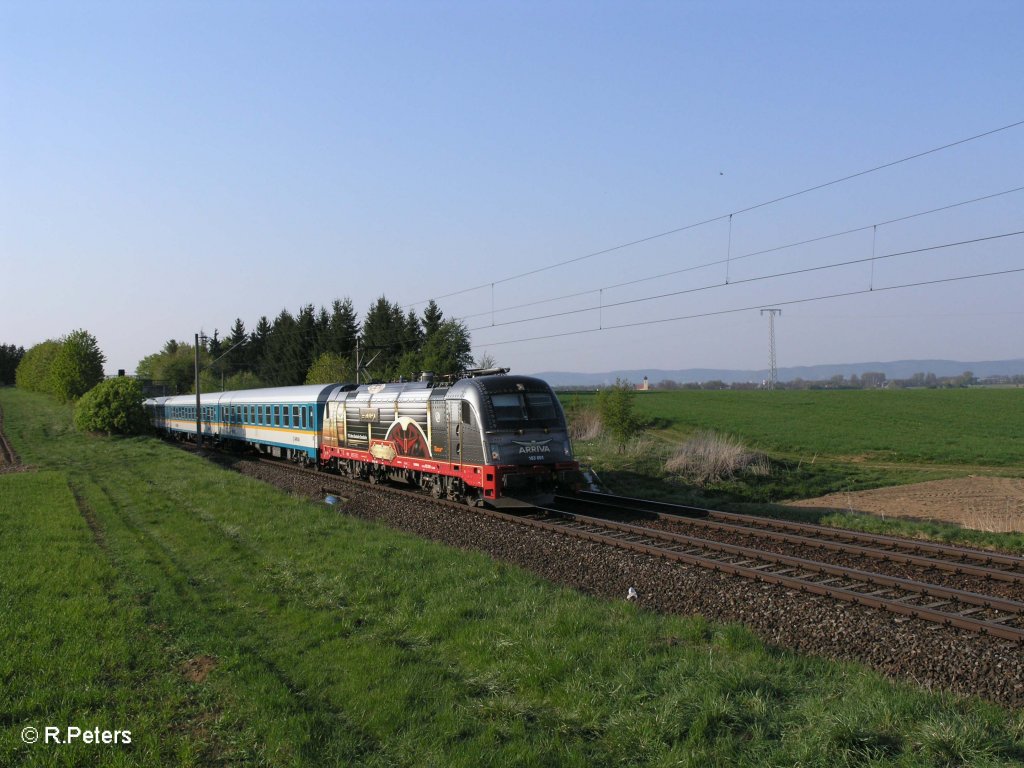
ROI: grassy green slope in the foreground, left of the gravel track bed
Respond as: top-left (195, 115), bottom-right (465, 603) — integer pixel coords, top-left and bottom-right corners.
top-left (6, 389), bottom-right (1024, 767)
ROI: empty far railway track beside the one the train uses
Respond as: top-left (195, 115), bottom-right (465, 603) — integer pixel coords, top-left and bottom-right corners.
top-left (556, 492), bottom-right (1024, 583)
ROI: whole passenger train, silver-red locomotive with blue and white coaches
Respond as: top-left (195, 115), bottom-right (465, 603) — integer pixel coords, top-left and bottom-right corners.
top-left (144, 369), bottom-right (580, 506)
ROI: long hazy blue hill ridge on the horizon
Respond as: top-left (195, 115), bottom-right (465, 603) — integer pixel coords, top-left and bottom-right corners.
top-left (532, 359), bottom-right (1024, 387)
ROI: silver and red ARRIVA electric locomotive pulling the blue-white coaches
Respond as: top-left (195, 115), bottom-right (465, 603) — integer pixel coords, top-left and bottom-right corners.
top-left (321, 369), bottom-right (580, 504)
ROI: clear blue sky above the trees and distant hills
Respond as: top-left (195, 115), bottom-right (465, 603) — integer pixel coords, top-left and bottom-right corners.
top-left (0, 0), bottom-right (1024, 373)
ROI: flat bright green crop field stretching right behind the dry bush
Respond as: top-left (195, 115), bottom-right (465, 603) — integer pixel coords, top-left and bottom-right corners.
top-left (635, 388), bottom-right (1024, 471)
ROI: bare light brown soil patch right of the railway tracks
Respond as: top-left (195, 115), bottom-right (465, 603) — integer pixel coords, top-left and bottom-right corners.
top-left (788, 477), bottom-right (1024, 532)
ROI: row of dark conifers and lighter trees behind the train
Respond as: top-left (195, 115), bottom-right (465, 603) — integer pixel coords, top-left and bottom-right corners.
top-left (135, 296), bottom-right (473, 394)
